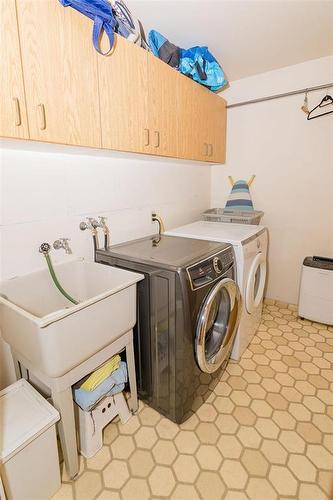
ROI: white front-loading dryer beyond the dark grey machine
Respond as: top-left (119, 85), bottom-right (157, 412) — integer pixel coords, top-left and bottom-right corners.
top-left (165, 221), bottom-right (268, 360)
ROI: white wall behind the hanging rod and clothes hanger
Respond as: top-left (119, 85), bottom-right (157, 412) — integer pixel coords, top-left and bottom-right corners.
top-left (212, 56), bottom-right (333, 303)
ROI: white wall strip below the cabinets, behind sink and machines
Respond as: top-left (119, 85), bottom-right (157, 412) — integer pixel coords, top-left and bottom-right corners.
top-left (0, 141), bottom-right (210, 387)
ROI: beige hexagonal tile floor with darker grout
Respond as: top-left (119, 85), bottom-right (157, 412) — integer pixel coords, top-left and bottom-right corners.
top-left (54, 301), bottom-right (333, 500)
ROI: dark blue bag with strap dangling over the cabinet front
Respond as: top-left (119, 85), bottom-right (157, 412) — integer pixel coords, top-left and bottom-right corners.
top-left (59, 0), bottom-right (117, 55)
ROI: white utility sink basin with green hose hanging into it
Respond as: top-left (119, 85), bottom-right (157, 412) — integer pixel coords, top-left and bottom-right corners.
top-left (0, 260), bottom-right (144, 378)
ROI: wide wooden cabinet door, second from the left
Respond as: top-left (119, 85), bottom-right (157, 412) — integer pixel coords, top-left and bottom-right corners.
top-left (16, 0), bottom-right (101, 147)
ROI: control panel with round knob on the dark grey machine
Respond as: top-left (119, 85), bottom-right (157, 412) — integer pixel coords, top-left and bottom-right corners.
top-left (186, 246), bottom-right (234, 290)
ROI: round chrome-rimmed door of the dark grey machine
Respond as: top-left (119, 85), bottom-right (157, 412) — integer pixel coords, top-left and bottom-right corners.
top-left (195, 278), bottom-right (241, 373)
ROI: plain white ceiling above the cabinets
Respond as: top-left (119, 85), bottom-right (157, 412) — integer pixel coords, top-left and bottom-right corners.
top-left (125, 0), bottom-right (333, 81)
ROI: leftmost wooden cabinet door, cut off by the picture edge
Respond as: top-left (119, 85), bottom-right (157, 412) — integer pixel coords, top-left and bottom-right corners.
top-left (0, 0), bottom-right (29, 139)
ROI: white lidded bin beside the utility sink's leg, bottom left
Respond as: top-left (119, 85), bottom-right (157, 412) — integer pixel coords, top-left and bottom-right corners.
top-left (0, 379), bottom-right (61, 500)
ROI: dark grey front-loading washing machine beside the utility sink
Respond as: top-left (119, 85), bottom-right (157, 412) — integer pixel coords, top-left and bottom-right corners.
top-left (96, 235), bottom-right (241, 423)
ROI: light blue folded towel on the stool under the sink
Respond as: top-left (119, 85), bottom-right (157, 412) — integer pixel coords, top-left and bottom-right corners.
top-left (73, 361), bottom-right (127, 411)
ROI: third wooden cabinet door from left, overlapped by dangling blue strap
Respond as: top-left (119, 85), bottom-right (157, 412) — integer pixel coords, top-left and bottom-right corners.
top-left (98, 36), bottom-right (149, 153)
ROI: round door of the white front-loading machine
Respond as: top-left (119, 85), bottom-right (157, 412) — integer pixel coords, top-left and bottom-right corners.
top-left (245, 252), bottom-right (267, 314)
